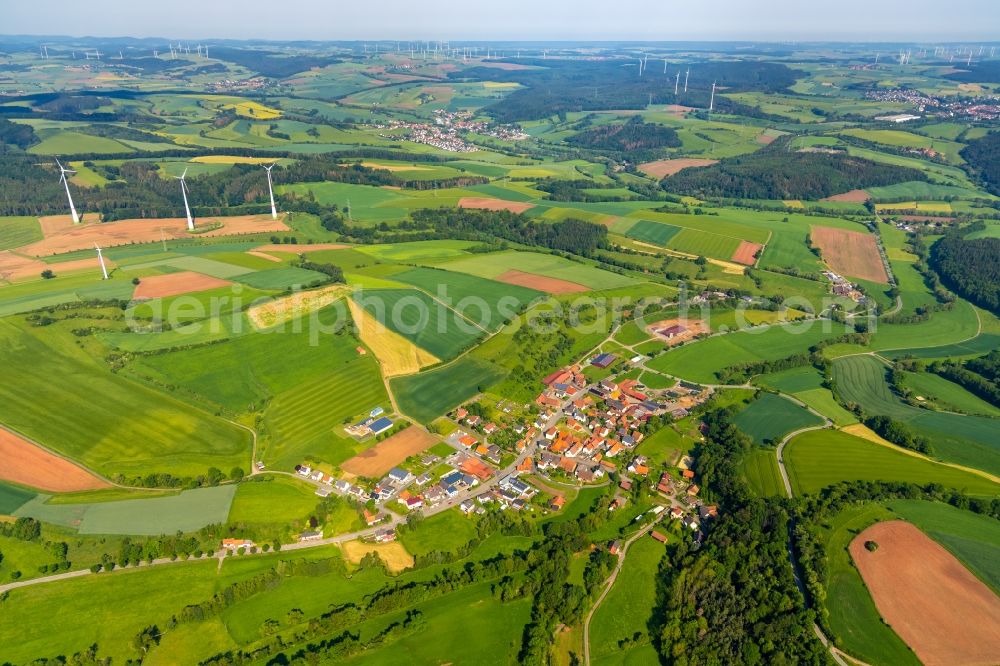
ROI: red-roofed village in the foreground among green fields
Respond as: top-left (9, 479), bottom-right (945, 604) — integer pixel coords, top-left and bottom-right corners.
top-left (282, 353), bottom-right (717, 543)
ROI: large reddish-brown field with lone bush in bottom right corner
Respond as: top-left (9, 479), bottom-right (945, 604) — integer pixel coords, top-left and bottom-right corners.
top-left (849, 520), bottom-right (1000, 666)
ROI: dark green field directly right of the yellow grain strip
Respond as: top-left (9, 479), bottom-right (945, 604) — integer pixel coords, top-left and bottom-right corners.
top-left (352, 289), bottom-right (486, 360)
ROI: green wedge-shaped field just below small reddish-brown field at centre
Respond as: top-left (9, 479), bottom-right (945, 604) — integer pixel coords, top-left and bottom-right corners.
top-left (392, 268), bottom-right (543, 331)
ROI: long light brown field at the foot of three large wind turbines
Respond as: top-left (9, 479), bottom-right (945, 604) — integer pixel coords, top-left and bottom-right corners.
top-left (18, 215), bottom-right (289, 257)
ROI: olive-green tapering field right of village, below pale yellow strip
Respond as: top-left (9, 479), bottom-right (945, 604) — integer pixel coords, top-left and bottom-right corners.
top-left (785, 430), bottom-right (1000, 496)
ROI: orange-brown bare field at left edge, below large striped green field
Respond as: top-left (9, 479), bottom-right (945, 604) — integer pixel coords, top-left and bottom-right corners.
top-left (0, 428), bottom-right (111, 493)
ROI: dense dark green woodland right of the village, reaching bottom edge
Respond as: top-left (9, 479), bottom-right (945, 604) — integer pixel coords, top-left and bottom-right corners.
top-left (656, 408), bottom-right (829, 666)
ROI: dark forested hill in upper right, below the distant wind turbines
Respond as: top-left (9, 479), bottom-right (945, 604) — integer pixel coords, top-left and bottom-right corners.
top-left (663, 137), bottom-right (927, 200)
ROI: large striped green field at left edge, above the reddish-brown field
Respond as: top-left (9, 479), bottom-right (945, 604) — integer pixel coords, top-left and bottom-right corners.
top-left (0, 318), bottom-right (250, 476)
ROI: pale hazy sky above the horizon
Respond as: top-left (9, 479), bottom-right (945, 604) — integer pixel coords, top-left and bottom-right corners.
top-left (0, 0), bottom-right (1000, 42)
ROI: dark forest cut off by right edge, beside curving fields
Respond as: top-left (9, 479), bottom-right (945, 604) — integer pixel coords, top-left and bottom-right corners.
top-left (929, 223), bottom-right (1000, 314)
